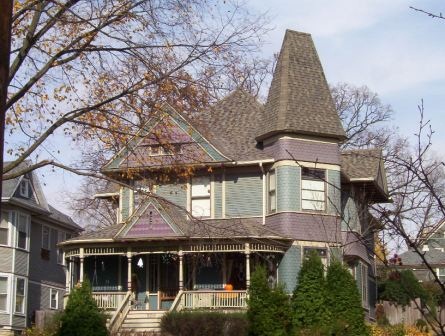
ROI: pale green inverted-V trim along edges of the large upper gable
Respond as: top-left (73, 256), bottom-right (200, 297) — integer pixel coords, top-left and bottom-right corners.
top-left (102, 104), bottom-right (230, 172)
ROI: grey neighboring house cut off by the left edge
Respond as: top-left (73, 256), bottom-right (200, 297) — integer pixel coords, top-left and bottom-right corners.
top-left (0, 162), bottom-right (82, 335)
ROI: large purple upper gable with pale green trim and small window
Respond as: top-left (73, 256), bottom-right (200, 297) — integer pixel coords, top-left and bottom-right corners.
top-left (103, 104), bottom-right (228, 172)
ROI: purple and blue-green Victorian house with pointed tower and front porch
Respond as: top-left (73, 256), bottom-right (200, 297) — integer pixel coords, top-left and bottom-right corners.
top-left (62, 31), bottom-right (388, 329)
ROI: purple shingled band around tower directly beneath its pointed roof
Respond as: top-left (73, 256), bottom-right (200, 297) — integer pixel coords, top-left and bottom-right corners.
top-left (264, 139), bottom-right (340, 164)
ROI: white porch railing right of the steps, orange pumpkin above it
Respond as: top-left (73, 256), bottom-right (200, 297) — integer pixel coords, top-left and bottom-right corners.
top-left (171, 290), bottom-right (247, 311)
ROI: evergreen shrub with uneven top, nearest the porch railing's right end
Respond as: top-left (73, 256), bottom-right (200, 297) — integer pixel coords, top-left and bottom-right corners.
top-left (247, 267), bottom-right (292, 336)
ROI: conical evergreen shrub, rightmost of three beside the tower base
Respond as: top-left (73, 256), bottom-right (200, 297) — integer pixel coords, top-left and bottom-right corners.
top-left (326, 260), bottom-right (369, 336)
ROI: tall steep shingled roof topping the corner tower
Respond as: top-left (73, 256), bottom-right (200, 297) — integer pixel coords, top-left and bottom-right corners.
top-left (257, 30), bottom-right (346, 140)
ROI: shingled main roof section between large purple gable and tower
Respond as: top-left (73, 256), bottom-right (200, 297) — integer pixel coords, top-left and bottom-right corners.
top-left (191, 89), bottom-right (268, 161)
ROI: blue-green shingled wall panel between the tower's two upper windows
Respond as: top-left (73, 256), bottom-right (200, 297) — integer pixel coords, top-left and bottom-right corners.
top-left (276, 166), bottom-right (301, 211)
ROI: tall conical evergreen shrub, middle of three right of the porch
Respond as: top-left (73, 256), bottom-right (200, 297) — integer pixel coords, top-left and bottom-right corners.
top-left (291, 251), bottom-right (331, 335)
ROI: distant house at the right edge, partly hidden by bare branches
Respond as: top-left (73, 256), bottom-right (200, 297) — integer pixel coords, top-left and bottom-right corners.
top-left (396, 219), bottom-right (445, 282)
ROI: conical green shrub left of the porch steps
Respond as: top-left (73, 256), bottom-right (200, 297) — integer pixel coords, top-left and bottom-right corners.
top-left (58, 281), bottom-right (108, 336)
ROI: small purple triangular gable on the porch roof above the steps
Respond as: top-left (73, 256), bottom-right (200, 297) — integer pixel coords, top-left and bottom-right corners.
top-left (116, 199), bottom-right (182, 239)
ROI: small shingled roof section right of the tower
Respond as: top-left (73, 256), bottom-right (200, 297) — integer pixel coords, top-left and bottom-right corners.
top-left (341, 149), bottom-right (382, 179)
